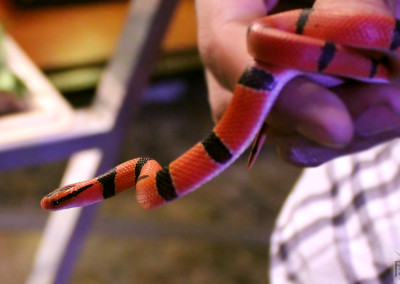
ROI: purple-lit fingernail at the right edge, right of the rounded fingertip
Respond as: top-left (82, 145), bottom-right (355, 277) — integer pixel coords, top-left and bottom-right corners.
top-left (355, 105), bottom-right (400, 136)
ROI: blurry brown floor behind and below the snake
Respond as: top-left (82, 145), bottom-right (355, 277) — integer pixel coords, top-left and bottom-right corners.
top-left (0, 72), bottom-right (299, 284)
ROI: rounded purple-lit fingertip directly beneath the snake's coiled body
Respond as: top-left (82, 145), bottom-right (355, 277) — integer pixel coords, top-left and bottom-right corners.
top-left (267, 77), bottom-right (353, 148)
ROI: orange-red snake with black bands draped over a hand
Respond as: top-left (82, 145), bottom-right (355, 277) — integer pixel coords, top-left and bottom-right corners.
top-left (41, 8), bottom-right (400, 210)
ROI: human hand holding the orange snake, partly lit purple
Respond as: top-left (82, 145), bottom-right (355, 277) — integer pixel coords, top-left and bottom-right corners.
top-left (197, 0), bottom-right (400, 166)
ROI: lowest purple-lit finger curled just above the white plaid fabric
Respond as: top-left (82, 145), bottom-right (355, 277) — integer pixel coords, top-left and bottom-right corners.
top-left (268, 83), bottom-right (400, 167)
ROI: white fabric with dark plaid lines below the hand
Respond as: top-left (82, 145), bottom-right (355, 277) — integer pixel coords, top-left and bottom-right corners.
top-left (270, 141), bottom-right (400, 284)
